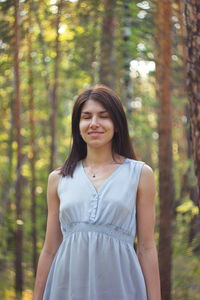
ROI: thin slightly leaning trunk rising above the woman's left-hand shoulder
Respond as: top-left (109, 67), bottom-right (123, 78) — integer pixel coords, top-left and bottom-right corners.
top-left (49, 0), bottom-right (63, 172)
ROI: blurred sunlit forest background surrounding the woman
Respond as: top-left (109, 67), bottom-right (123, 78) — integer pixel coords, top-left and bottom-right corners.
top-left (0, 0), bottom-right (200, 300)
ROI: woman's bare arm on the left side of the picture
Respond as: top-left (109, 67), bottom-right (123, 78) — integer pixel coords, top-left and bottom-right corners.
top-left (33, 171), bottom-right (62, 300)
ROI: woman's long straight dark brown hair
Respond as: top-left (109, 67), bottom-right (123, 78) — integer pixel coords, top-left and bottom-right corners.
top-left (59, 84), bottom-right (136, 176)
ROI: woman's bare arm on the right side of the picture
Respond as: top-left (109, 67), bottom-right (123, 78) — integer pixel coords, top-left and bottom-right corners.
top-left (137, 164), bottom-right (161, 300)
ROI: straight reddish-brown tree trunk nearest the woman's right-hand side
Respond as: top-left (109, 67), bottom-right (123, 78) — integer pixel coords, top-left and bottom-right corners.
top-left (156, 0), bottom-right (174, 300)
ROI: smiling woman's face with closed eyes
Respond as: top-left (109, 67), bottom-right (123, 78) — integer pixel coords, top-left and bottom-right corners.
top-left (79, 100), bottom-right (114, 148)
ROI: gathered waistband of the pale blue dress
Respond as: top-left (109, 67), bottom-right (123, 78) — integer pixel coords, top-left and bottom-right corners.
top-left (62, 223), bottom-right (133, 245)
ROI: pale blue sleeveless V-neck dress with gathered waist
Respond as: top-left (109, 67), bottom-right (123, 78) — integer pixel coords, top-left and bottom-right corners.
top-left (43, 158), bottom-right (147, 300)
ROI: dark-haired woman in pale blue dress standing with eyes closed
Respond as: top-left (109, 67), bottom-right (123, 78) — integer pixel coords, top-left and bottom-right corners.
top-left (33, 85), bottom-right (161, 300)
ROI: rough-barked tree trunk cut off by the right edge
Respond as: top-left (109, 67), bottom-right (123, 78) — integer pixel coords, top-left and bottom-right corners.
top-left (185, 0), bottom-right (200, 205)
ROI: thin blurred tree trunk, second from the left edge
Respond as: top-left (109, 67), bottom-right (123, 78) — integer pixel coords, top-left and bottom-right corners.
top-left (27, 0), bottom-right (38, 275)
